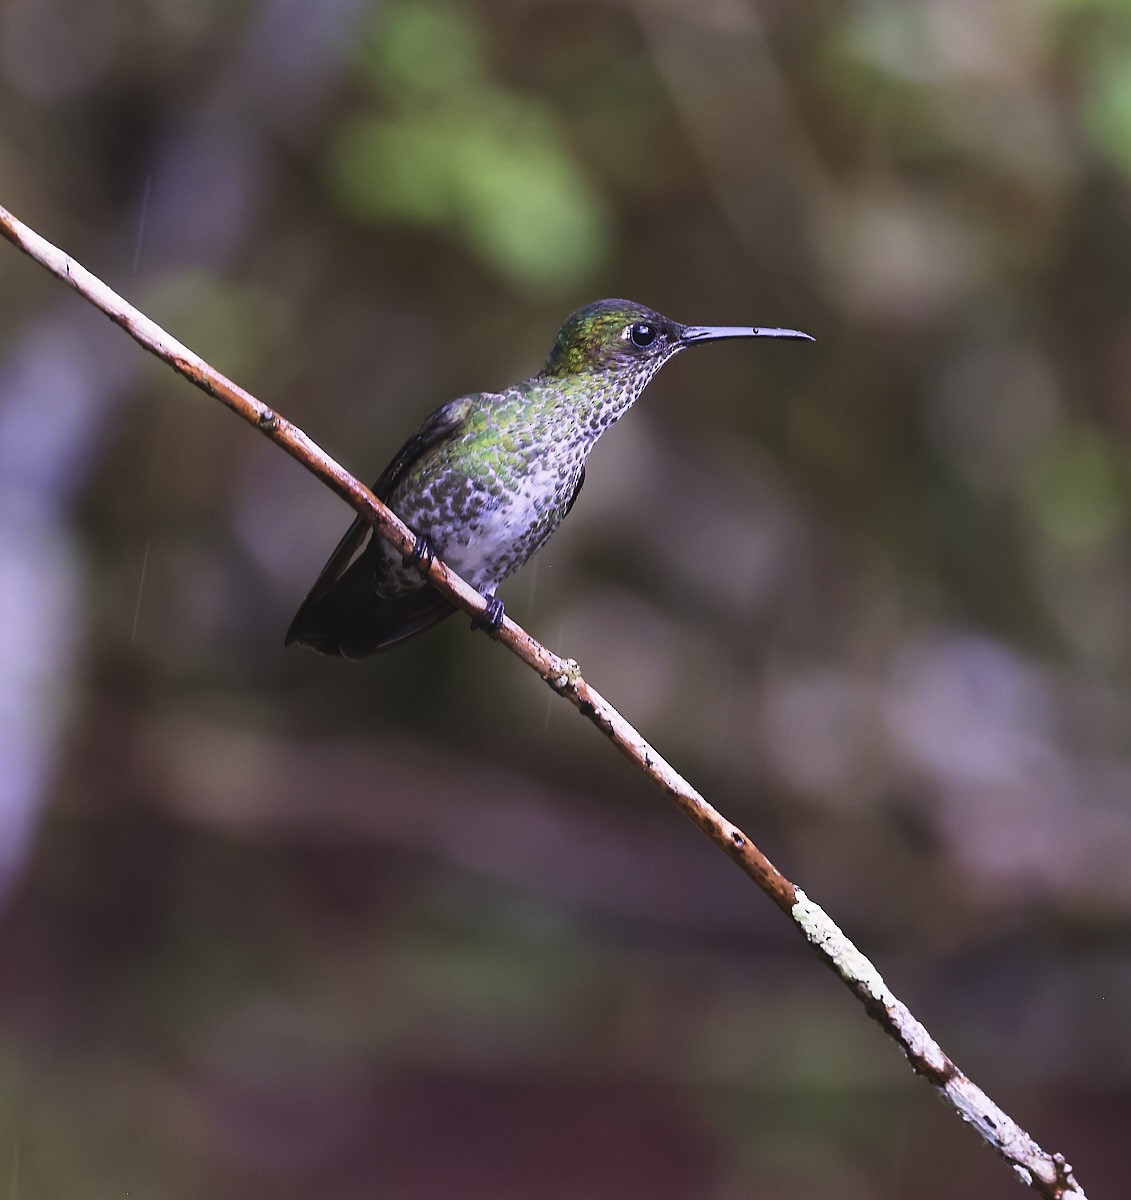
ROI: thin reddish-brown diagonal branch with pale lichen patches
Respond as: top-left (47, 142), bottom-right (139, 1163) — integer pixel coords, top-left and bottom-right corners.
top-left (0, 208), bottom-right (1084, 1200)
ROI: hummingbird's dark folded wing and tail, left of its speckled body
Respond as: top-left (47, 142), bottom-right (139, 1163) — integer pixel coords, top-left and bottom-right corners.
top-left (283, 396), bottom-right (477, 659)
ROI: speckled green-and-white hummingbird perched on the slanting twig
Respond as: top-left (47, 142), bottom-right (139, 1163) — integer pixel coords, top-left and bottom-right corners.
top-left (286, 300), bottom-right (813, 659)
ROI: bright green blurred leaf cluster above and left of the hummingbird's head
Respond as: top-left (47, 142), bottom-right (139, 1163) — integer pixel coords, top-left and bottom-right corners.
top-left (328, 2), bottom-right (611, 294)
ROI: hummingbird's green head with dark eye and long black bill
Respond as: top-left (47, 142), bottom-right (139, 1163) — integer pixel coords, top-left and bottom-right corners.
top-left (541, 300), bottom-right (813, 427)
